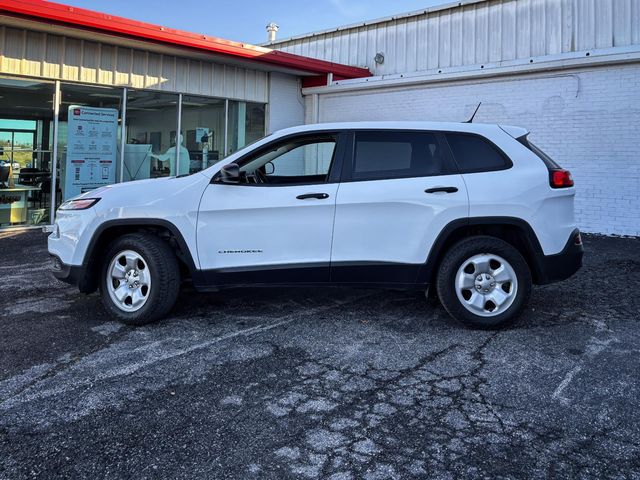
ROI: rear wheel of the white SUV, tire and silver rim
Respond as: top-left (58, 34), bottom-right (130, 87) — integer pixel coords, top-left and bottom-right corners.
top-left (437, 236), bottom-right (531, 328)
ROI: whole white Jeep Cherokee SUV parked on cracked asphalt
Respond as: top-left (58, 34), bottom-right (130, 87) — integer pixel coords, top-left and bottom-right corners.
top-left (49, 122), bottom-right (583, 327)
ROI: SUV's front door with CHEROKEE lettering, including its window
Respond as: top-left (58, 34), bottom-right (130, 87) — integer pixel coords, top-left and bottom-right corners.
top-left (197, 133), bottom-right (341, 285)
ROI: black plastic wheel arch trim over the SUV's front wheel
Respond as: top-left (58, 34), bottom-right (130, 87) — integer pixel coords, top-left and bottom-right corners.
top-left (78, 218), bottom-right (197, 293)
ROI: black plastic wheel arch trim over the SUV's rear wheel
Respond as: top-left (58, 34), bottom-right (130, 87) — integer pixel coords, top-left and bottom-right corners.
top-left (418, 217), bottom-right (544, 285)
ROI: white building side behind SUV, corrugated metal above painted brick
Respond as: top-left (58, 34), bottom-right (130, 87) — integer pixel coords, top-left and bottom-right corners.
top-left (269, 0), bottom-right (640, 236)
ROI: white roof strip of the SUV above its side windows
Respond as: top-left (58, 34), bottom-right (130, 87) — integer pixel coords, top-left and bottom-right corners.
top-left (276, 121), bottom-right (528, 136)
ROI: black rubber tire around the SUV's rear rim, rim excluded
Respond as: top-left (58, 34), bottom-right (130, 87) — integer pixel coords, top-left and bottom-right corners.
top-left (436, 236), bottom-right (532, 329)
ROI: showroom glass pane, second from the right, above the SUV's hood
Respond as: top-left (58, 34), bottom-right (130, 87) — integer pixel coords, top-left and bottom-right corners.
top-left (181, 95), bottom-right (225, 173)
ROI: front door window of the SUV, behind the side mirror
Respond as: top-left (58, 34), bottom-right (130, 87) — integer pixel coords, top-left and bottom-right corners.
top-left (240, 135), bottom-right (337, 185)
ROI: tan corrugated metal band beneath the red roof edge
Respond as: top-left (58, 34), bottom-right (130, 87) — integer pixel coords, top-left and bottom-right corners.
top-left (0, 26), bottom-right (268, 103)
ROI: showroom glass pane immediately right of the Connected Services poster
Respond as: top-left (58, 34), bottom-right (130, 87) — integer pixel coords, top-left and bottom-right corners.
top-left (124, 89), bottom-right (179, 178)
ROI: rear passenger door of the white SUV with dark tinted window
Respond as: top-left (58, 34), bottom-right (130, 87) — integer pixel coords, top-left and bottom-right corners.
top-left (331, 130), bottom-right (469, 284)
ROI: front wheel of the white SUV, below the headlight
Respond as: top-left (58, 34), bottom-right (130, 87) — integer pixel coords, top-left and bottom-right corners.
top-left (100, 233), bottom-right (180, 325)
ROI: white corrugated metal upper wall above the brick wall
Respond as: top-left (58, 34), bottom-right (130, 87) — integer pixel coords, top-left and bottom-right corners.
top-left (270, 0), bottom-right (640, 75)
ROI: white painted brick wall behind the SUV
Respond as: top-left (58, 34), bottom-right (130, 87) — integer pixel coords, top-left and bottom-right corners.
top-left (306, 64), bottom-right (640, 236)
